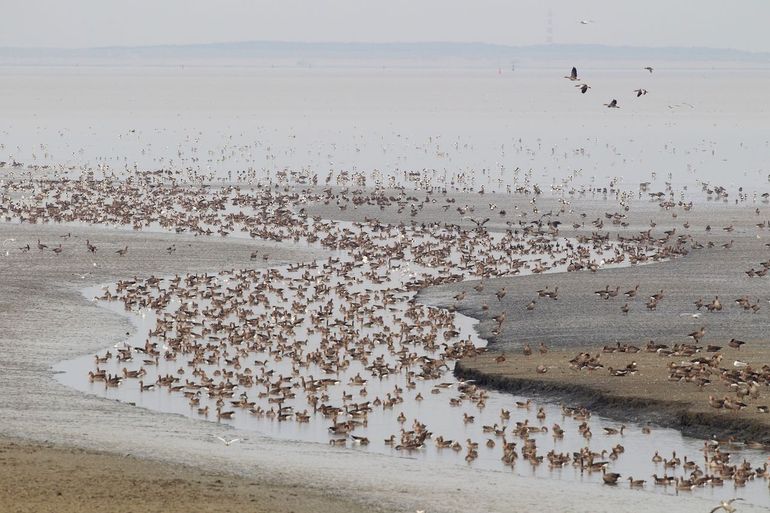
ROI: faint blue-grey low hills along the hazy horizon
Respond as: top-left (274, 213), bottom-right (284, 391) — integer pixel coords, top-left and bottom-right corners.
top-left (0, 41), bottom-right (770, 71)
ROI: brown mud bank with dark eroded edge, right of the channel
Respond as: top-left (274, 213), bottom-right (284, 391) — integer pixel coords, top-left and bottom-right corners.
top-left (455, 343), bottom-right (770, 443)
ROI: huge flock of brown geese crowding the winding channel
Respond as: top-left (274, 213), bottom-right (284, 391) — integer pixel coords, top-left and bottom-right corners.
top-left (0, 166), bottom-right (768, 510)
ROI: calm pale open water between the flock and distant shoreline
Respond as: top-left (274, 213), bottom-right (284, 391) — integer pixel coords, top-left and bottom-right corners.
top-left (0, 66), bottom-right (770, 192)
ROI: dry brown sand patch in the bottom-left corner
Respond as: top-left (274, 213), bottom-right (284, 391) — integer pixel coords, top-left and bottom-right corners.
top-left (0, 438), bottom-right (376, 513)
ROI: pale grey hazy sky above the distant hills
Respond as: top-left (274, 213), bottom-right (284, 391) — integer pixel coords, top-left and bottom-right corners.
top-left (6, 0), bottom-right (770, 51)
